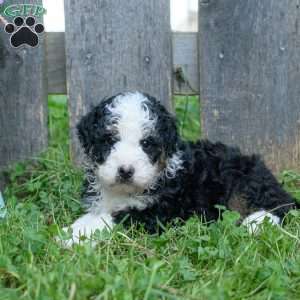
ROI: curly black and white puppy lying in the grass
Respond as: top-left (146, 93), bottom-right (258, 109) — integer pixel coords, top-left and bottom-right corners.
top-left (62, 92), bottom-right (298, 245)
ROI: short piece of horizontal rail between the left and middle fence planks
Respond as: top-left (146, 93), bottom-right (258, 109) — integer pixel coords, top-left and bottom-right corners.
top-left (46, 32), bottom-right (67, 94)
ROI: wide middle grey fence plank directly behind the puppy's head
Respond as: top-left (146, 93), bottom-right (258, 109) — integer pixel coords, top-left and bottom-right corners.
top-left (65, 0), bottom-right (172, 163)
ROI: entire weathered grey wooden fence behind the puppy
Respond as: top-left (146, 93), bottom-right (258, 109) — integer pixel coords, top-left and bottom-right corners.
top-left (0, 0), bottom-right (300, 188)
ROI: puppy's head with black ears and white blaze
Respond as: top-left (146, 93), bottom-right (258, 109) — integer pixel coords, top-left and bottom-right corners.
top-left (78, 93), bottom-right (182, 194)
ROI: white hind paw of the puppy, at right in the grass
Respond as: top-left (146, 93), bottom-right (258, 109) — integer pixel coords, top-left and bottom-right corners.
top-left (242, 210), bottom-right (280, 234)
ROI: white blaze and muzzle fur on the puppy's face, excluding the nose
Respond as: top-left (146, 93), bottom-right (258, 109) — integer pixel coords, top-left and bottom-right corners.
top-left (97, 93), bottom-right (158, 194)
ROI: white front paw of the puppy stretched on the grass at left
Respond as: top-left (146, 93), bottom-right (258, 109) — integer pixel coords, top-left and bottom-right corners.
top-left (57, 213), bottom-right (113, 248)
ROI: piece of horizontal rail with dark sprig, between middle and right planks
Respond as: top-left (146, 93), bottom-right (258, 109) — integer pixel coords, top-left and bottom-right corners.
top-left (172, 32), bottom-right (199, 95)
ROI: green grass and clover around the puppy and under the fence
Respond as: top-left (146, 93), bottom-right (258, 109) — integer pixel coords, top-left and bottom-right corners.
top-left (0, 97), bottom-right (300, 300)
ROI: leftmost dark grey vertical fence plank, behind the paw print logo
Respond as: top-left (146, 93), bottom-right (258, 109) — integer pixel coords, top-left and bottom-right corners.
top-left (0, 0), bottom-right (47, 175)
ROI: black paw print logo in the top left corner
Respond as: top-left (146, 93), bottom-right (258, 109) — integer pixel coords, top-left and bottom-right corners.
top-left (5, 17), bottom-right (45, 48)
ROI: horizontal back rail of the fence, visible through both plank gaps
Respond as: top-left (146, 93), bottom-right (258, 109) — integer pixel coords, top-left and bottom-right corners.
top-left (46, 32), bottom-right (199, 95)
